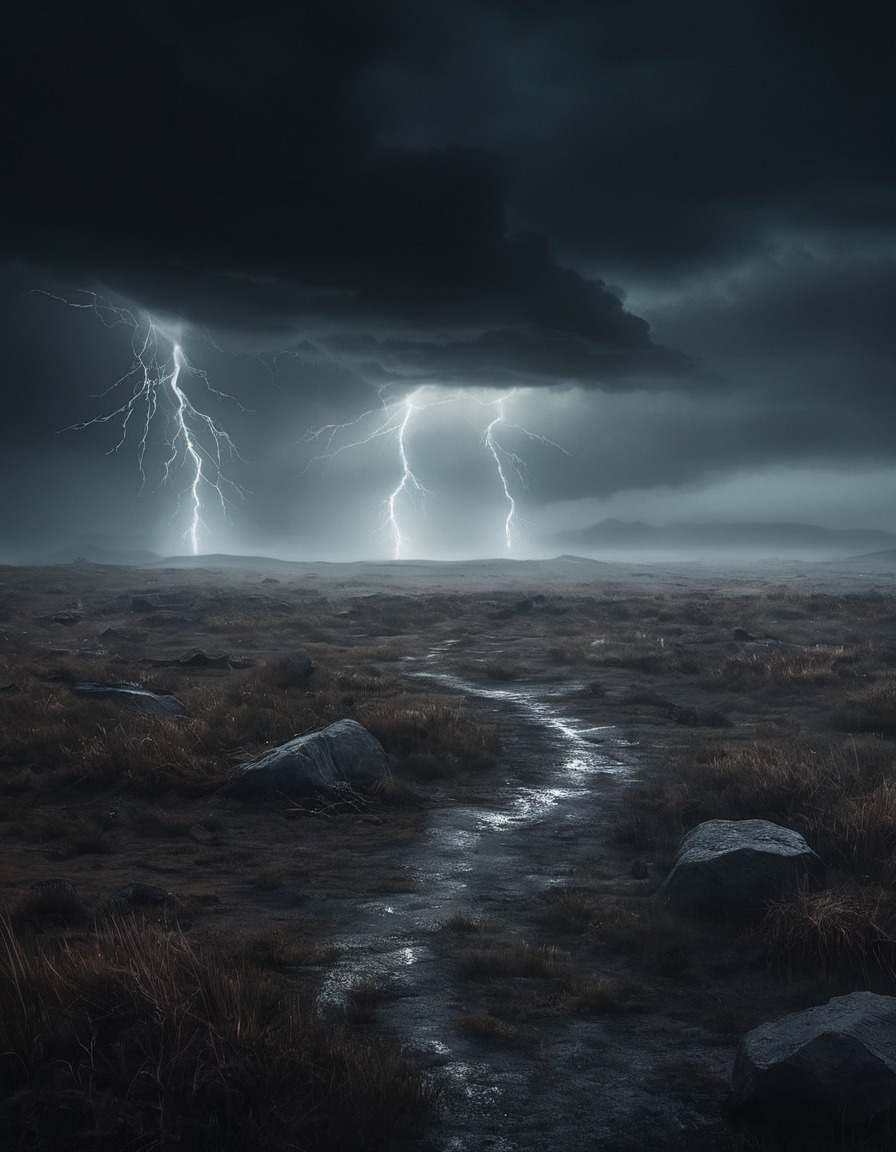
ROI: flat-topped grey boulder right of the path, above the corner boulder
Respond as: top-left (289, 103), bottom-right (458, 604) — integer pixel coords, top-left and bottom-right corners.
top-left (660, 820), bottom-right (818, 912)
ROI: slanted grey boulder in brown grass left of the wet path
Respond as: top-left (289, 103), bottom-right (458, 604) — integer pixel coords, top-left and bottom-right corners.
top-left (231, 720), bottom-right (387, 796)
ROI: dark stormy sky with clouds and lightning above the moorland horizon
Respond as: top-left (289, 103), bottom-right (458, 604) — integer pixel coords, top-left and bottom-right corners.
top-left (0, 0), bottom-right (896, 561)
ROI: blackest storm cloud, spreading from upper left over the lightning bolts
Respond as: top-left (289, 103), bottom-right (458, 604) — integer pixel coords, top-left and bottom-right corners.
top-left (2, 0), bottom-right (704, 387)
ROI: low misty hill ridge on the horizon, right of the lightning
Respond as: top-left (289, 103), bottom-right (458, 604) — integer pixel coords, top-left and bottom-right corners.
top-left (552, 520), bottom-right (896, 559)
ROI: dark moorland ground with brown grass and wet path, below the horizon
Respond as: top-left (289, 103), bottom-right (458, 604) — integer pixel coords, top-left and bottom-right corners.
top-left (0, 558), bottom-right (896, 1152)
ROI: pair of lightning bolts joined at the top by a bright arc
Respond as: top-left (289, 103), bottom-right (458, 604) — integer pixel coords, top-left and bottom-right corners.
top-left (303, 385), bottom-right (569, 560)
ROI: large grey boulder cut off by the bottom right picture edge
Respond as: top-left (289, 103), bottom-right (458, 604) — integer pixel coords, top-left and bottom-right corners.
top-left (734, 992), bottom-right (896, 1124)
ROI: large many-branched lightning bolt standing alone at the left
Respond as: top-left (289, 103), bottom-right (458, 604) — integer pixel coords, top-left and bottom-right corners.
top-left (33, 289), bottom-right (246, 555)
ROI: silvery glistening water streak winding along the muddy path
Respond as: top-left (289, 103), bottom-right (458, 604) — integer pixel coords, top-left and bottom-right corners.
top-left (319, 652), bottom-right (631, 1152)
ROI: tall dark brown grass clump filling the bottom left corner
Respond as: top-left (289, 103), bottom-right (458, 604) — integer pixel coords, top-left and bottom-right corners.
top-left (0, 916), bottom-right (436, 1152)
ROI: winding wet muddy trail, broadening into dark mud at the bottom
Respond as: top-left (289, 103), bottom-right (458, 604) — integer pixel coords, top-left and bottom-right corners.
top-left (306, 652), bottom-right (731, 1152)
